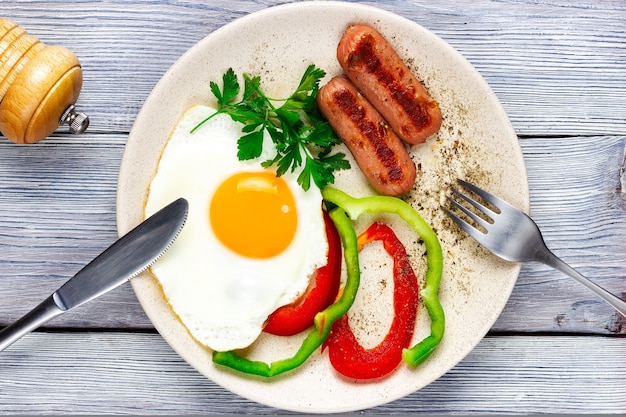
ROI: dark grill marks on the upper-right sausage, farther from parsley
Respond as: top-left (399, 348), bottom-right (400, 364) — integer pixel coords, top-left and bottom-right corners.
top-left (348, 34), bottom-right (431, 135)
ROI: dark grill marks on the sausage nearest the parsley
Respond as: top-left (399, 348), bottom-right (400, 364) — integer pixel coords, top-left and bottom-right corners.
top-left (333, 90), bottom-right (404, 182)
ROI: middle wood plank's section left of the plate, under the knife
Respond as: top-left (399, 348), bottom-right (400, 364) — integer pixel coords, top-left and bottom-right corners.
top-left (0, 134), bottom-right (152, 328)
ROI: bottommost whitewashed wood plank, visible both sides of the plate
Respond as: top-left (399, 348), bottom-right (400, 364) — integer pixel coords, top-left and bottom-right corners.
top-left (0, 332), bottom-right (626, 415)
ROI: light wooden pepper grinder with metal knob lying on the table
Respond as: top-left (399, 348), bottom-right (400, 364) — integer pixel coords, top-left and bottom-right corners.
top-left (0, 17), bottom-right (89, 143)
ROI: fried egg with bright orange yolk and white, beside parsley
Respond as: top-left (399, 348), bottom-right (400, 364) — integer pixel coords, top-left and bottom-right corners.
top-left (145, 105), bottom-right (328, 351)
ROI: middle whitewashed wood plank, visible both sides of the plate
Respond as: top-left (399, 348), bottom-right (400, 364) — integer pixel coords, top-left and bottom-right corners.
top-left (0, 135), bottom-right (626, 334)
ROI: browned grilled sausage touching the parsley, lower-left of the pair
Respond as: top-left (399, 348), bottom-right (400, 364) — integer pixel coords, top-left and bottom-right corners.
top-left (317, 76), bottom-right (416, 195)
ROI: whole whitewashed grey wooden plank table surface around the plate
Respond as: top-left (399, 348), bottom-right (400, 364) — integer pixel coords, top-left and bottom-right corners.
top-left (0, 0), bottom-right (626, 415)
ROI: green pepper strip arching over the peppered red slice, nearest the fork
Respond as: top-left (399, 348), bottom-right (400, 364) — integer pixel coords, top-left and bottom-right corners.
top-left (322, 187), bottom-right (445, 367)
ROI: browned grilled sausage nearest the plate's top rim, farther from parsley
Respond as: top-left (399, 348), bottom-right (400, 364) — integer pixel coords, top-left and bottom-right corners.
top-left (337, 25), bottom-right (441, 145)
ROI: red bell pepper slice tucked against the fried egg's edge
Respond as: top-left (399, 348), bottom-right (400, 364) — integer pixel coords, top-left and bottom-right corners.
top-left (263, 211), bottom-right (342, 336)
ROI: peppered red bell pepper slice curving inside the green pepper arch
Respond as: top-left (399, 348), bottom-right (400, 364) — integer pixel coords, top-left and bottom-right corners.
top-left (323, 223), bottom-right (419, 379)
